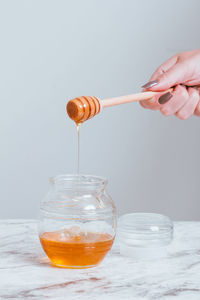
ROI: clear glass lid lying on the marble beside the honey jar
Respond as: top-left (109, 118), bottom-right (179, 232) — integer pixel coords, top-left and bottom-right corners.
top-left (118, 213), bottom-right (173, 259)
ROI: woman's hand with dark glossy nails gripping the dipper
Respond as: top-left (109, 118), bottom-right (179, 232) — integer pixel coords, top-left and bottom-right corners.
top-left (140, 50), bottom-right (200, 120)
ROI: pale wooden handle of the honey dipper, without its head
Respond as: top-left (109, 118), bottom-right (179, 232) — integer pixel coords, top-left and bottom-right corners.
top-left (101, 89), bottom-right (172, 107)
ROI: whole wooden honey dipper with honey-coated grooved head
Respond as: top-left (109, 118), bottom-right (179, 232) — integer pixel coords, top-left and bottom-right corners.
top-left (67, 89), bottom-right (172, 124)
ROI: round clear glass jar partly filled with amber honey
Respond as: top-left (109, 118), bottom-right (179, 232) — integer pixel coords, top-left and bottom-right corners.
top-left (39, 175), bottom-right (117, 268)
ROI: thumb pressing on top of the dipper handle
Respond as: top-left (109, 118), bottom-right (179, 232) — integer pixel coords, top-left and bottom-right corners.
top-left (149, 63), bottom-right (187, 91)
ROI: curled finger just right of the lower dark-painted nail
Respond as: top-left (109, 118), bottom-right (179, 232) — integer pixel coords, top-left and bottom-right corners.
top-left (160, 85), bottom-right (189, 116)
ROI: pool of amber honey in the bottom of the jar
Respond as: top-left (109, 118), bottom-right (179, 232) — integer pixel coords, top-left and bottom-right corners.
top-left (40, 231), bottom-right (114, 268)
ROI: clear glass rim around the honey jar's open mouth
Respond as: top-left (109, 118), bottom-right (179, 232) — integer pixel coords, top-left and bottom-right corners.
top-left (49, 174), bottom-right (108, 187)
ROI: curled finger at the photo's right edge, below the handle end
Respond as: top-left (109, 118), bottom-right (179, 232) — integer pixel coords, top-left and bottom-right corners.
top-left (176, 88), bottom-right (200, 120)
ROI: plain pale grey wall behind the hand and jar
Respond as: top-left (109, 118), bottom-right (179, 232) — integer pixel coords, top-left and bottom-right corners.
top-left (0, 0), bottom-right (200, 220)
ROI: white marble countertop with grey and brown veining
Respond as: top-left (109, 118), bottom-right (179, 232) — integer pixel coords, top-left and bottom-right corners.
top-left (0, 220), bottom-right (200, 300)
